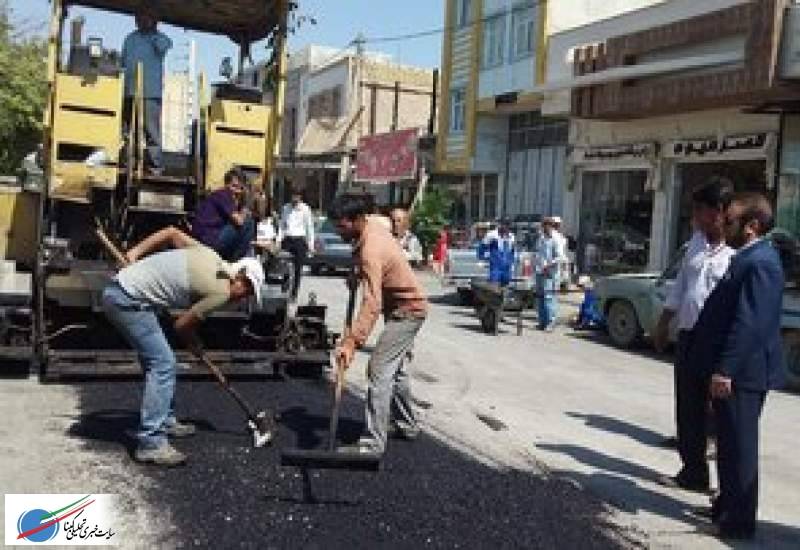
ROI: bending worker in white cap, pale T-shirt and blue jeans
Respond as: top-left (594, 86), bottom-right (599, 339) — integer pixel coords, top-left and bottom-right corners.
top-left (102, 227), bottom-right (264, 466)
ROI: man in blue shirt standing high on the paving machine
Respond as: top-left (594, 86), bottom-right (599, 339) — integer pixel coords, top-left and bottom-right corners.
top-left (121, 2), bottom-right (172, 174)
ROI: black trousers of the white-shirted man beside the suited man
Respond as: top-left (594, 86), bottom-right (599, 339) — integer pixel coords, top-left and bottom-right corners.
top-left (675, 331), bottom-right (710, 483)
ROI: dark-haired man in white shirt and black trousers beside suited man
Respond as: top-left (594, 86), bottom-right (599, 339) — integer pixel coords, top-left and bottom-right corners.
top-left (653, 178), bottom-right (735, 491)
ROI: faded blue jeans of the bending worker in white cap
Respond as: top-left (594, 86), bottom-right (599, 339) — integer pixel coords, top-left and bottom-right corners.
top-left (103, 282), bottom-right (177, 449)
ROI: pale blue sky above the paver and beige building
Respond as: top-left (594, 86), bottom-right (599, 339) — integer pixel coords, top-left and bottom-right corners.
top-left (9, 0), bottom-right (444, 80)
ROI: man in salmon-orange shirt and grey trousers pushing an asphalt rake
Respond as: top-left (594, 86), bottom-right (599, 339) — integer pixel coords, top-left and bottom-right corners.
top-left (328, 195), bottom-right (428, 453)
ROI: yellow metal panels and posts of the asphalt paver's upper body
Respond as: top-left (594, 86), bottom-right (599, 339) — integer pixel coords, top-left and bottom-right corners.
top-left (44, 0), bottom-right (289, 202)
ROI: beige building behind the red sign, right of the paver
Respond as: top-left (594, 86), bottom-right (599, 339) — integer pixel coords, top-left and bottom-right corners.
top-left (245, 46), bottom-right (434, 209)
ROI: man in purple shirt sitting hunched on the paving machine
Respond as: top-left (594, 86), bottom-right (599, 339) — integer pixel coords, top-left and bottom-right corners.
top-left (192, 169), bottom-right (256, 262)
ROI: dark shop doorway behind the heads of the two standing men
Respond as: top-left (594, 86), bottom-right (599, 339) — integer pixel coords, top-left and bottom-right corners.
top-left (672, 160), bottom-right (775, 251)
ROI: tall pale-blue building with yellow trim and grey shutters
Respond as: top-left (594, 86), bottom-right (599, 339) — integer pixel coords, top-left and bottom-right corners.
top-left (437, 0), bottom-right (663, 227)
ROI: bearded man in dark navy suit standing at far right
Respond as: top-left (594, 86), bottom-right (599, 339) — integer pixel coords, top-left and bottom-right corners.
top-left (692, 193), bottom-right (785, 538)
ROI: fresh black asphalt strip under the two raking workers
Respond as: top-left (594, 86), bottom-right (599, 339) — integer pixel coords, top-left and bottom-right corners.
top-left (70, 380), bottom-right (620, 549)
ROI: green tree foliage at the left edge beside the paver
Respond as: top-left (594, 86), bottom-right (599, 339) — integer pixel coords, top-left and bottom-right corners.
top-left (0, 2), bottom-right (47, 174)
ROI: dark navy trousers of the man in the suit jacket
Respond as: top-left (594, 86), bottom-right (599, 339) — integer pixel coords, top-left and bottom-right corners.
top-left (713, 389), bottom-right (767, 530)
